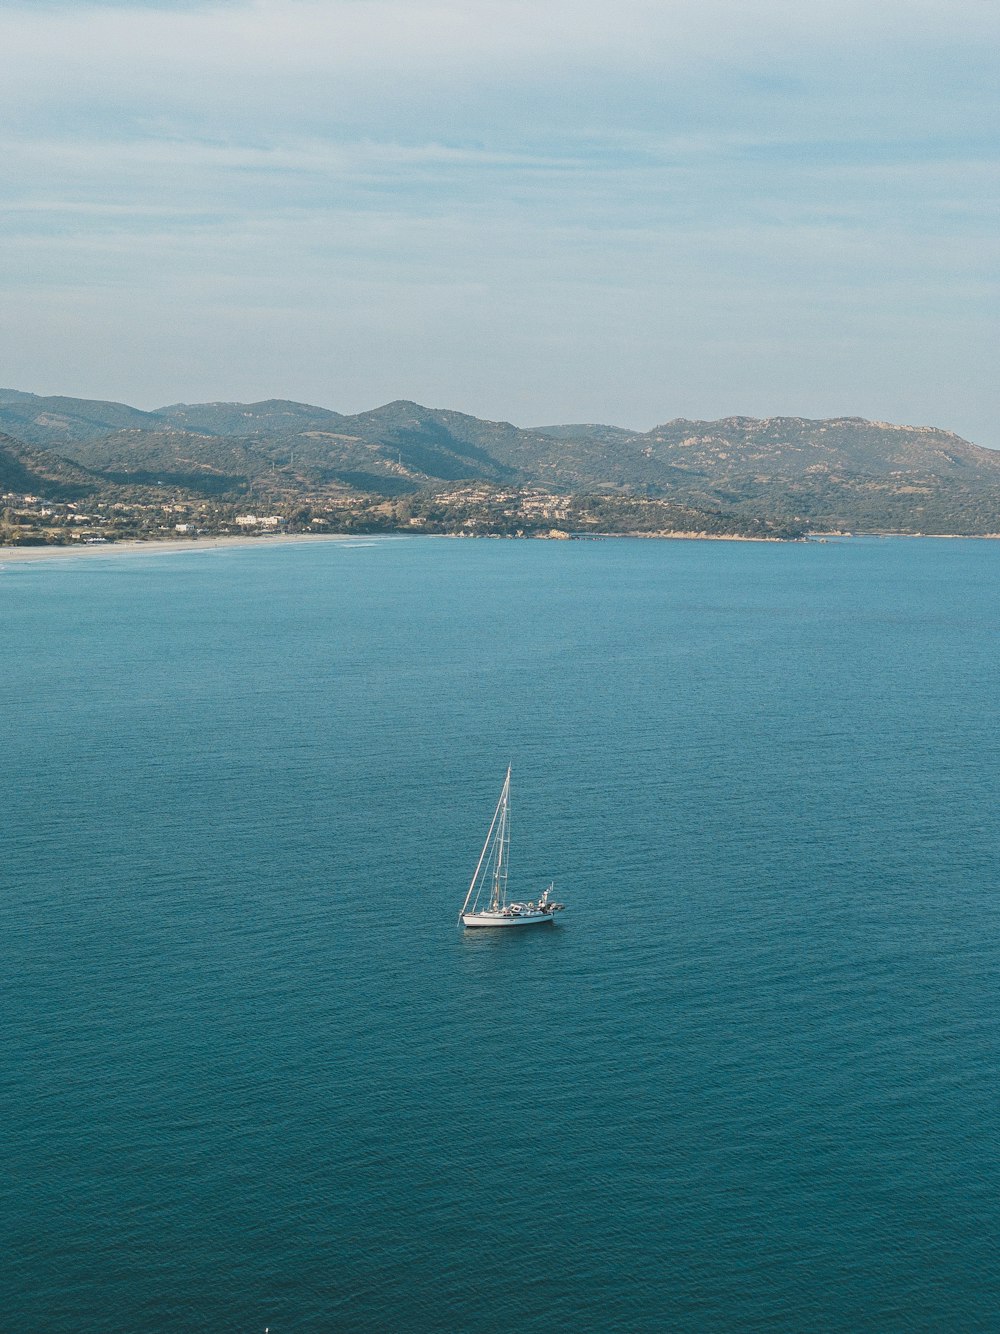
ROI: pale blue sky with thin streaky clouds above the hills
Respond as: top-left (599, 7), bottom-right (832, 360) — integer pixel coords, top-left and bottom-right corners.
top-left (0, 0), bottom-right (1000, 447)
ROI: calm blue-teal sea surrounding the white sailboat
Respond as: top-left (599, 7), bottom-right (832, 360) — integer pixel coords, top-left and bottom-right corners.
top-left (0, 539), bottom-right (1000, 1334)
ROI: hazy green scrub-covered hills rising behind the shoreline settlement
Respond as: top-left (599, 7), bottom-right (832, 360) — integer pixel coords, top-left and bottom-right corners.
top-left (0, 390), bottom-right (1000, 532)
